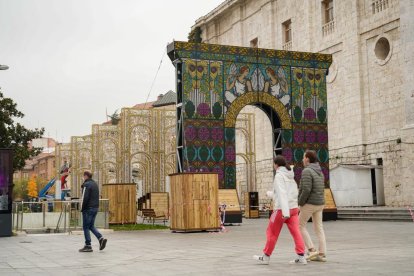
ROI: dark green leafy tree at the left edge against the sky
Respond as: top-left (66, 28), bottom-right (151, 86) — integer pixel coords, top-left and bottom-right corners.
top-left (0, 91), bottom-right (45, 171)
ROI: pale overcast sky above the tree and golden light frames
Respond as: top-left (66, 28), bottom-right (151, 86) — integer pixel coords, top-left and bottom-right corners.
top-left (0, 0), bottom-right (222, 142)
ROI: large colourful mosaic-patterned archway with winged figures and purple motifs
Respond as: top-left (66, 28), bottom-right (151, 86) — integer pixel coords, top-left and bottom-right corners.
top-left (167, 41), bottom-right (332, 188)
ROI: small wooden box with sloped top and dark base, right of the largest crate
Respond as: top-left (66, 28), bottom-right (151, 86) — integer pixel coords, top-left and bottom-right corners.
top-left (218, 189), bottom-right (243, 224)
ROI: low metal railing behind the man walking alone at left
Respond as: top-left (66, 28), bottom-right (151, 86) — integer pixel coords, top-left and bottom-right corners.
top-left (12, 199), bottom-right (109, 233)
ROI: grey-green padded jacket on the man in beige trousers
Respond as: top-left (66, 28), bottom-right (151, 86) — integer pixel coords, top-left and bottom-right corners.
top-left (298, 163), bottom-right (325, 206)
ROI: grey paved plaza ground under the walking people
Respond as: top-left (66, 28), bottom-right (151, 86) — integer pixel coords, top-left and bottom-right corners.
top-left (0, 219), bottom-right (414, 276)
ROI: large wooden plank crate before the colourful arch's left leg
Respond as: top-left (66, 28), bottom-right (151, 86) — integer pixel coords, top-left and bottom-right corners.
top-left (170, 173), bottom-right (220, 231)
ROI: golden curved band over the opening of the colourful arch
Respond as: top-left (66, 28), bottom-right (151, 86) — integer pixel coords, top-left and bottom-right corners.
top-left (224, 92), bottom-right (292, 129)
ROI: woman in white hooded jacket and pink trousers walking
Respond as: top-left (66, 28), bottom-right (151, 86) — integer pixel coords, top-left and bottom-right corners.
top-left (254, 155), bottom-right (307, 264)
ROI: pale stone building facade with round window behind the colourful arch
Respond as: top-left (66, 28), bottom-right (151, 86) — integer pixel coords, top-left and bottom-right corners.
top-left (193, 0), bottom-right (414, 206)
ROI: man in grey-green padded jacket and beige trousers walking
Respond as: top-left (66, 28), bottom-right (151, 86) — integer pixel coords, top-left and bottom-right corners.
top-left (298, 150), bottom-right (326, 262)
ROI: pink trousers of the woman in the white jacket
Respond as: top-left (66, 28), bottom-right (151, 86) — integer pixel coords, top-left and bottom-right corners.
top-left (263, 208), bottom-right (305, 256)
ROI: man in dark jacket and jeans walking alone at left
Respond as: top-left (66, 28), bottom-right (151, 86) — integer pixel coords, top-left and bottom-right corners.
top-left (79, 171), bottom-right (107, 252)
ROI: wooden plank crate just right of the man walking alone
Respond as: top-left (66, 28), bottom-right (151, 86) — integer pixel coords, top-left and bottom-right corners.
top-left (102, 183), bottom-right (137, 224)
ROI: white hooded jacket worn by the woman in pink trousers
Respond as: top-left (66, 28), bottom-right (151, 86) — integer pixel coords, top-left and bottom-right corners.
top-left (268, 167), bottom-right (298, 217)
